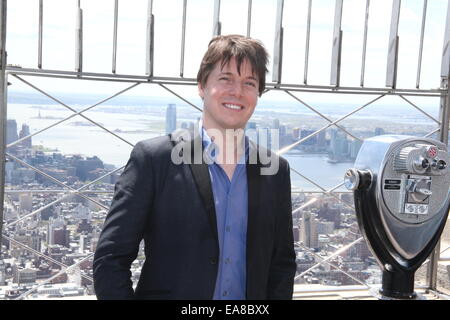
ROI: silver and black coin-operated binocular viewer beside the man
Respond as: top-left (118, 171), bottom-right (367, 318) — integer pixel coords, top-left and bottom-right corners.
top-left (345, 135), bottom-right (450, 299)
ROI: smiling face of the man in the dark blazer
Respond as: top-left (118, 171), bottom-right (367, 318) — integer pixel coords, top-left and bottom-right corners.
top-left (198, 58), bottom-right (259, 130)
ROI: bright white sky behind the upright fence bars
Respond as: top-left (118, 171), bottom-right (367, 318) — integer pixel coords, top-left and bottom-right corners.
top-left (6, 0), bottom-right (448, 104)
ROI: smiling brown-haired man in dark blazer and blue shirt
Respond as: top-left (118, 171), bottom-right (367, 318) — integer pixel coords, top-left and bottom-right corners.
top-left (94, 35), bottom-right (296, 299)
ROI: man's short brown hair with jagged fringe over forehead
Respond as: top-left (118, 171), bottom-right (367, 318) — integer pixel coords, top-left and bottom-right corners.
top-left (197, 34), bottom-right (268, 96)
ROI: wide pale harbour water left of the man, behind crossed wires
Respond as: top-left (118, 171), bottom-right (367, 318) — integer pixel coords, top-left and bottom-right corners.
top-left (8, 104), bottom-right (163, 167)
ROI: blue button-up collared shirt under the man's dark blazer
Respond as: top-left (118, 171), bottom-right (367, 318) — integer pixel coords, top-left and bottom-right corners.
top-left (199, 121), bottom-right (248, 300)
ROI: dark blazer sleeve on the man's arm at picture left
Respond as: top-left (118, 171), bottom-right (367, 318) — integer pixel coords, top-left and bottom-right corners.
top-left (93, 142), bottom-right (152, 299)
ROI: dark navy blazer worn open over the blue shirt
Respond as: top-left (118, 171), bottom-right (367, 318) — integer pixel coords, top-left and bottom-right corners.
top-left (93, 128), bottom-right (296, 300)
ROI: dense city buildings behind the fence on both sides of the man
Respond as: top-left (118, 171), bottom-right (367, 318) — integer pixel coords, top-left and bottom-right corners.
top-left (0, 94), bottom-right (448, 298)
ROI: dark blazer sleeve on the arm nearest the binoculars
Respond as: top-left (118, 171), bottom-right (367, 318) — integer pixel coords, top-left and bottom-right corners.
top-left (267, 161), bottom-right (297, 300)
